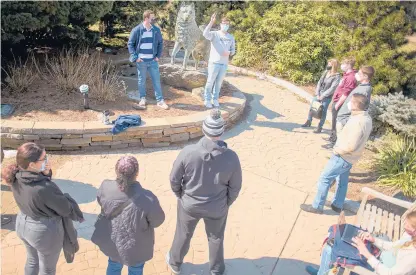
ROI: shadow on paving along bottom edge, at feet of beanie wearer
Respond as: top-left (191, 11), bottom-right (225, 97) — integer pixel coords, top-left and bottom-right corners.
top-left (177, 258), bottom-right (318, 275)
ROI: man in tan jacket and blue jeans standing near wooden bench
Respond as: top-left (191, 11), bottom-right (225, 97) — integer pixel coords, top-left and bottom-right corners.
top-left (301, 94), bottom-right (373, 214)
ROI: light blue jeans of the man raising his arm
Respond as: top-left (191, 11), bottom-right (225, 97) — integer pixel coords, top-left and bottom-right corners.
top-left (205, 63), bottom-right (228, 101)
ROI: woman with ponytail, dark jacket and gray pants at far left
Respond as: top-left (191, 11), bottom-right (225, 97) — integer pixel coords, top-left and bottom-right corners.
top-left (2, 143), bottom-right (83, 275)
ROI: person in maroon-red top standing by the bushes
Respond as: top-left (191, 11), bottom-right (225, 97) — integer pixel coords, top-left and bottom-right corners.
top-left (329, 57), bottom-right (357, 144)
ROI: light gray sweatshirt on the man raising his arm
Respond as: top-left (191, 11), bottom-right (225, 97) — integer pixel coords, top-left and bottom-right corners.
top-left (203, 24), bottom-right (235, 65)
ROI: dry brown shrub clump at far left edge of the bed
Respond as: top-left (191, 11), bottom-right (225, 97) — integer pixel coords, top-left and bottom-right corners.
top-left (1, 54), bottom-right (39, 94)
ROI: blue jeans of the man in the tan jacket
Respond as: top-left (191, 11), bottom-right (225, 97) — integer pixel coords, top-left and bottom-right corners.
top-left (312, 155), bottom-right (352, 210)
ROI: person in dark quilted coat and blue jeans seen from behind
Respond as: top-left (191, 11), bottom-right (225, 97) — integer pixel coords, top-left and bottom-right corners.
top-left (91, 156), bottom-right (165, 275)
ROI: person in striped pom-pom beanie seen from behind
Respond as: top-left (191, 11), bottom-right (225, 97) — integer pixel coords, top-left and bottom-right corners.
top-left (166, 109), bottom-right (242, 275)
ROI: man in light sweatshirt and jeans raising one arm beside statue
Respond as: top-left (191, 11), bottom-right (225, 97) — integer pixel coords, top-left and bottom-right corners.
top-left (203, 13), bottom-right (235, 108)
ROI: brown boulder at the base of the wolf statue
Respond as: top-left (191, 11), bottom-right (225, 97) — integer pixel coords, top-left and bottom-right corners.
top-left (159, 64), bottom-right (207, 91)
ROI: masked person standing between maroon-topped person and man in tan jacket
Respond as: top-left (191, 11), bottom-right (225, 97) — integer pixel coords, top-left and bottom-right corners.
top-left (336, 66), bottom-right (375, 135)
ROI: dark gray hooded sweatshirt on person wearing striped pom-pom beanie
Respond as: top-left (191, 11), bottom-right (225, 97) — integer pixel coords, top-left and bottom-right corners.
top-left (170, 137), bottom-right (242, 215)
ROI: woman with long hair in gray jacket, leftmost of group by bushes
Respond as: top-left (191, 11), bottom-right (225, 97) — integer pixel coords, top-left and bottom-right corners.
top-left (302, 59), bottom-right (341, 133)
